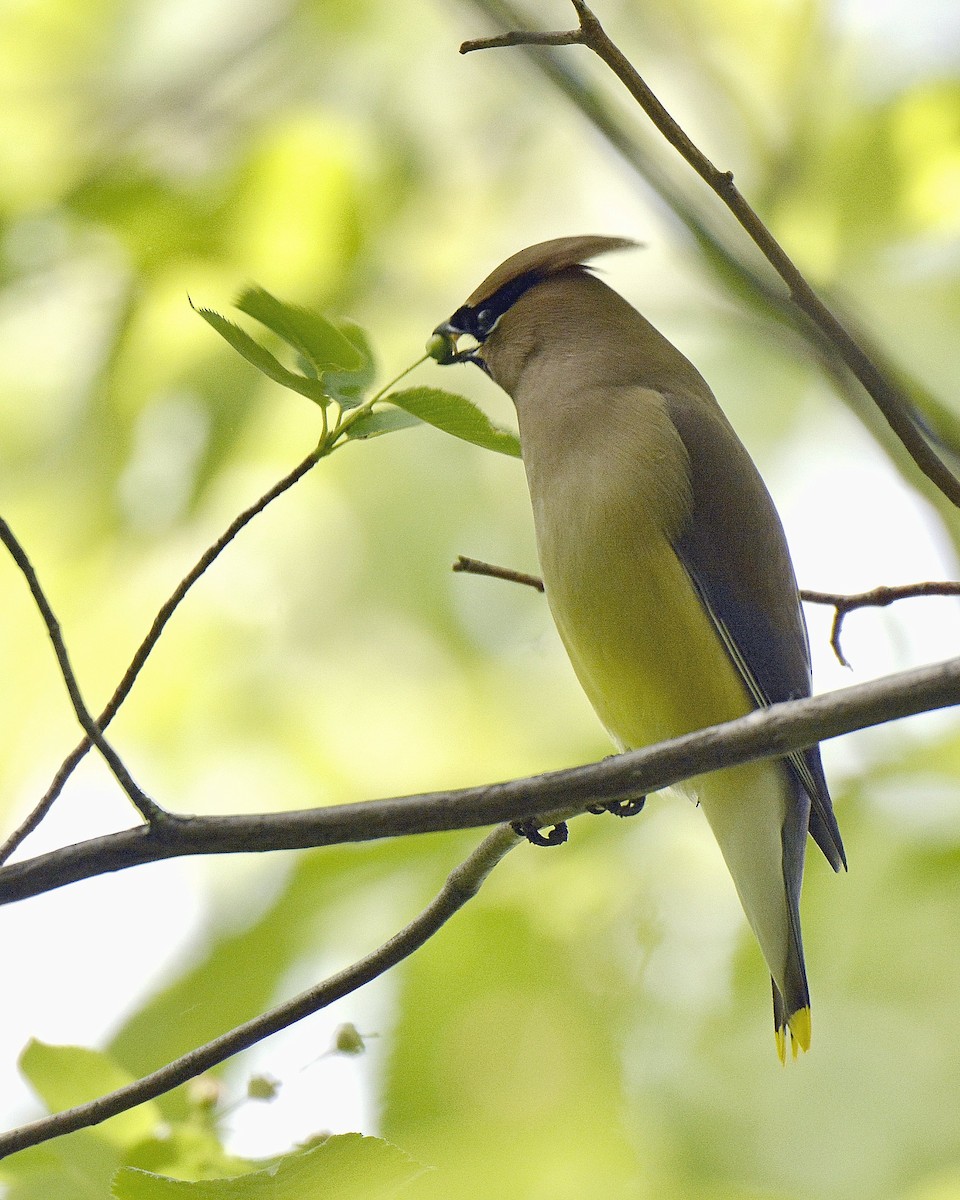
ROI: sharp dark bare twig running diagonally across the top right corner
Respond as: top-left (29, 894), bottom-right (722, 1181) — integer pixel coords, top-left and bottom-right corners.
top-left (460, 0), bottom-right (960, 508)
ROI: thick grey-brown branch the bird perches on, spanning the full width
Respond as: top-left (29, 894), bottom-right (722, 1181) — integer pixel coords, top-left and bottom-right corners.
top-left (0, 658), bottom-right (960, 904)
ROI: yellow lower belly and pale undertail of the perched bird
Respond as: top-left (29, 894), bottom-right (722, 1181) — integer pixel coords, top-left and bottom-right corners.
top-left (540, 529), bottom-right (791, 988)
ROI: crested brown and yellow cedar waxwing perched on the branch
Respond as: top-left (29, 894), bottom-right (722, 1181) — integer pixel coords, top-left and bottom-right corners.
top-left (427, 236), bottom-right (846, 1061)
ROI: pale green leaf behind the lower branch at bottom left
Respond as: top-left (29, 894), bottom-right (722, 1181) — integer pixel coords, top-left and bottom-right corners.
top-left (20, 1040), bottom-right (161, 1145)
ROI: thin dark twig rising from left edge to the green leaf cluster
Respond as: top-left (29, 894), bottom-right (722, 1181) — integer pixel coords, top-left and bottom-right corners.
top-left (0, 448), bottom-right (322, 863)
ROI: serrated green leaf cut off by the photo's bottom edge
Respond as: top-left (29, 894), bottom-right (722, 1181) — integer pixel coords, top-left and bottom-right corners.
top-left (113, 1133), bottom-right (424, 1200)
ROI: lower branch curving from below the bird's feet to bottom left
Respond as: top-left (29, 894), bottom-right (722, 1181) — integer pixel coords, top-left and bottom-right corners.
top-left (0, 826), bottom-right (520, 1158)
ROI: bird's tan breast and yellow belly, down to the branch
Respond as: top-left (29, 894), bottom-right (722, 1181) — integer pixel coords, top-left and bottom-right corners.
top-left (517, 379), bottom-right (752, 748)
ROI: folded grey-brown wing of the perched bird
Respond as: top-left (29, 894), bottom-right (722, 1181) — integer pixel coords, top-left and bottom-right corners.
top-left (665, 395), bottom-right (846, 870)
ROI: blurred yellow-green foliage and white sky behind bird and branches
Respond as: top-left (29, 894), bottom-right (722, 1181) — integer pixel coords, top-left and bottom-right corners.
top-left (0, 0), bottom-right (960, 1200)
